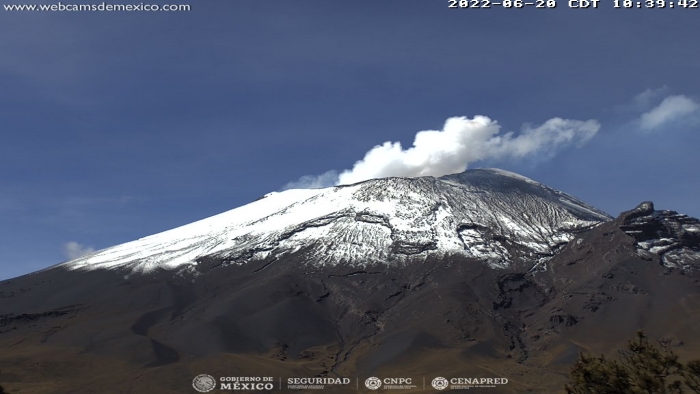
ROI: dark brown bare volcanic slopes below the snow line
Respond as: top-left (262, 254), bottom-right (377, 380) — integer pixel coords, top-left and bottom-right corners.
top-left (0, 195), bottom-right (700, 393)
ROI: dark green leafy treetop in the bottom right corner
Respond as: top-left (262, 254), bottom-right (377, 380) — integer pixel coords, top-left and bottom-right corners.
top-left (565, 331), bottom-right (700, 394)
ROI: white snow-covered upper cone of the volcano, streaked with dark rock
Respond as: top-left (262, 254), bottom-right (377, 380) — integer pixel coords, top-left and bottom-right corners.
top-left (61, 169), bottom-right (611, 272)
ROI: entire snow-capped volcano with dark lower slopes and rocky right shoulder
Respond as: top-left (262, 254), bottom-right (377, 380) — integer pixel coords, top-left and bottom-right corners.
top-left (0, 169), bottom-right (700, 393)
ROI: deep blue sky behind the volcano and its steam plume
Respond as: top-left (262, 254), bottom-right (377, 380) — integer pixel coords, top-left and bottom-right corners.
top-left (0, 0), bottom-right (700, 279)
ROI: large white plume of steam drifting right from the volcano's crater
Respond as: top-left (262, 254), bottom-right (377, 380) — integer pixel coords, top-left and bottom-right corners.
top-left (287, 116), bottom-right (600, 188)
